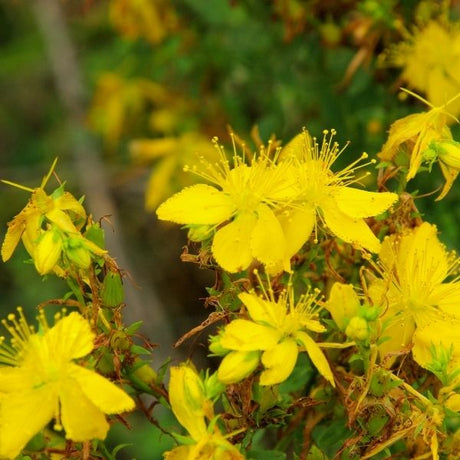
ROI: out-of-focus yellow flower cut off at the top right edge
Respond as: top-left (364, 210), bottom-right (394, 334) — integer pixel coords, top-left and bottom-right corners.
top-left (389, 20), bottom-right (460, 115)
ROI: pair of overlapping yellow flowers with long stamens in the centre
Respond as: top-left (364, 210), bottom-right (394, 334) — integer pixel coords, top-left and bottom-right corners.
top-left (157, 131), bottom-right (397, 273)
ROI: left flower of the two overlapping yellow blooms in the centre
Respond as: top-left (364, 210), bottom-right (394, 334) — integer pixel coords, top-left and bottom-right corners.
top-left (157, 140), bottom-right (292, 272)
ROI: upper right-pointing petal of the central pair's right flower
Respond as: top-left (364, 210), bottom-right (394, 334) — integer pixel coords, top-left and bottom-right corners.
top-left (330, 187), bottom-right (398, 218)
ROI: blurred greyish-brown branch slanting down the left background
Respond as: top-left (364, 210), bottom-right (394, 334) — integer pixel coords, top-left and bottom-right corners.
top-left (33, 0), bottom-right (174, 357)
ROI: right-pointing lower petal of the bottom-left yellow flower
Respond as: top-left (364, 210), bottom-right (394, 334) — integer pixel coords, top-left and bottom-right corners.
top-left (69, 364), bottom-right (135, 414)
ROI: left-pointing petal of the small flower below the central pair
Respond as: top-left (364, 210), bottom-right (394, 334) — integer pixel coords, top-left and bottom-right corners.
top-left (220, 319), bottom-right (281, 351)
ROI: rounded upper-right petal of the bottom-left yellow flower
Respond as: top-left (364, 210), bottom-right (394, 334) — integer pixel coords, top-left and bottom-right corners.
top-left (44, 312), bottom-right (96, 361)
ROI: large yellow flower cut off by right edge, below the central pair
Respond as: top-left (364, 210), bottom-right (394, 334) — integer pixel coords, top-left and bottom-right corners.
top-left (369, 222), bottom-right (460, 367)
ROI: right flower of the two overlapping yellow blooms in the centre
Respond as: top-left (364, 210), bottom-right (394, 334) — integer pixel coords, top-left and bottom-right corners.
top-left (280, 130), bottom-right (398, 257)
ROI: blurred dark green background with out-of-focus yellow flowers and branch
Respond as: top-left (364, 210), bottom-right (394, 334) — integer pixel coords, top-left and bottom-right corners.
top-left (0, 0), bottom-right (460, 458)
